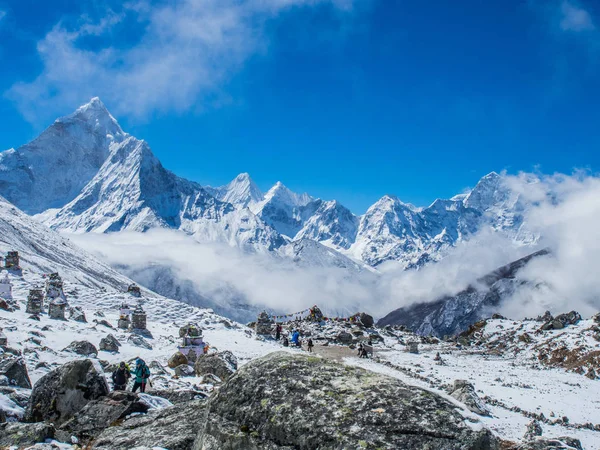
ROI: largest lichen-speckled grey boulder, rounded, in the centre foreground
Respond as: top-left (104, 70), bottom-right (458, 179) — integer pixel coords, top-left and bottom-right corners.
top-left (193, 352), bottom-right (498, 450)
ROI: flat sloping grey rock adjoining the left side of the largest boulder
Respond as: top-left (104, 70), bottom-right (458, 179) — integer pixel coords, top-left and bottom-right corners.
top-left (92, 400), bottom-right (206, 450)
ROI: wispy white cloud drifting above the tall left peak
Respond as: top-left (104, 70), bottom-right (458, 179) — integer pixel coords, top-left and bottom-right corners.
top-left (6, 0), bottom-right (352, 121)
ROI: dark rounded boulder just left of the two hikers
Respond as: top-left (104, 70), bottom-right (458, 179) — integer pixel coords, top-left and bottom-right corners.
top-left (25, 359), bottom-right (109, 425)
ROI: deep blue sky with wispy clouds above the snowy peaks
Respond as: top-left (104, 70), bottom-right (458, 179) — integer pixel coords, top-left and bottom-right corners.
top-left (0, 0), bottom-right (600, 213)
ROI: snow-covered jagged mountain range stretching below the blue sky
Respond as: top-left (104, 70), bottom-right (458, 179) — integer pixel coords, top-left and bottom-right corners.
top-left (0, 98), bottom-right (539, 324)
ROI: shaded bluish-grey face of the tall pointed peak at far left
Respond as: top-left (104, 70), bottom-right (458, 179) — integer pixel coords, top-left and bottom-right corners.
top-left (0, 98), bottom-right (127, 214)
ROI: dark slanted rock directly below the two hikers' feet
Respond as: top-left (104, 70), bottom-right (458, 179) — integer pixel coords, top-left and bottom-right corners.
top-left (56, 391), bottom-right (148, 443)
